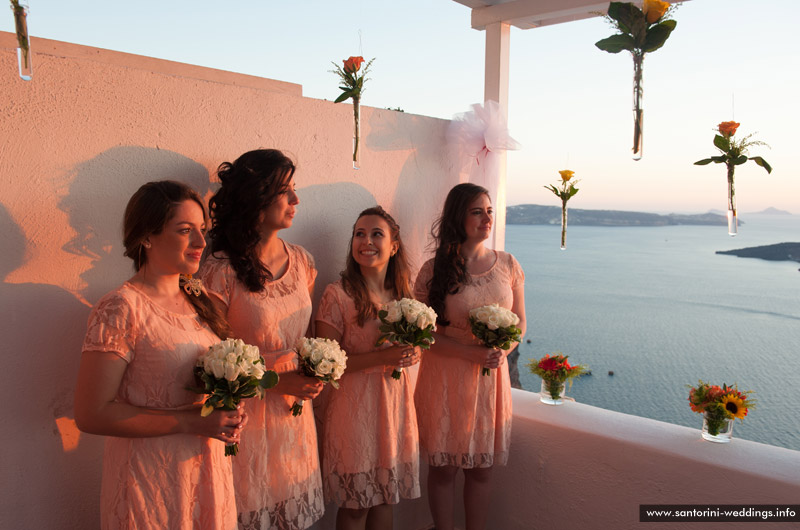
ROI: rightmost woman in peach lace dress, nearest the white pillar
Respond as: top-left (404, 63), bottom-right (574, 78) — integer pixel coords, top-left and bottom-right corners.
top-left (415, 183), bottom-right (525, 530)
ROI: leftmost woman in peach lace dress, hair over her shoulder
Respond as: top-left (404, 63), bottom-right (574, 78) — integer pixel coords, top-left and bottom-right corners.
top-left (75, 181), bottom-right (246, 530)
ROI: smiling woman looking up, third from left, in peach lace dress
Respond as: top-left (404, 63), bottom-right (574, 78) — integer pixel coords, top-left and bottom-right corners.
top-left (316, 206), bottom-right (420, 530)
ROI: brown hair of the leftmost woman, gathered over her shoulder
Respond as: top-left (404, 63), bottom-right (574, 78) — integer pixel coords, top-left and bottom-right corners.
top-left (122, 180), bottom-right (232, 339)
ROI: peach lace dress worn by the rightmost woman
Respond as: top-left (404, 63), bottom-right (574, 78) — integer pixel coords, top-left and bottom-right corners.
top-left (414, 251), bottom-right (525, 469)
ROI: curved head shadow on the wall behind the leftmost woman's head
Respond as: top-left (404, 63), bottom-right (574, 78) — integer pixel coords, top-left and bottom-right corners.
top-left (59, 146), bottom-right (211, 304)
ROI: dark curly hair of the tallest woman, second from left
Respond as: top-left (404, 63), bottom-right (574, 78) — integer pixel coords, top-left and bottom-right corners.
top-left (208, 149), bottom-right (296, 293)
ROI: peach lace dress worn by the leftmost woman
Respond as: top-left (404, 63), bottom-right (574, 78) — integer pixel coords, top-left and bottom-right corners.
top-left (83, 282), bottom-right (236, 530)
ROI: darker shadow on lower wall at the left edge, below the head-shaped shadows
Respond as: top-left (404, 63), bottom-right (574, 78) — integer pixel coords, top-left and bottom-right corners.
top-left (0, 200), bottom-right (102, 528)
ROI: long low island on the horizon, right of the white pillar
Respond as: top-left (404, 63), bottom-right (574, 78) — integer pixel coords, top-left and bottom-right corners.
top-left (506, 204), bottom-right (736, 226)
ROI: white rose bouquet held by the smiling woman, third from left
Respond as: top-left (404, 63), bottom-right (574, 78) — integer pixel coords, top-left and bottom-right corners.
top-left (376, 298), bottom-right (436, 379)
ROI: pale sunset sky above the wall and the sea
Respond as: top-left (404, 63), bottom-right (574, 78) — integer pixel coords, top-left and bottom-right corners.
top-left (0, 0), bottom-right (800, 214)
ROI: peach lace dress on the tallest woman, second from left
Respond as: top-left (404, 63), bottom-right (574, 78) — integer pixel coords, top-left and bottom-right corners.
top-left (200, 243), bottom-right (324, 530)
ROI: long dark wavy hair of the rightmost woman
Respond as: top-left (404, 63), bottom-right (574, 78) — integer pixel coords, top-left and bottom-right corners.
top-left (427, 182), bottom-right (489, 326)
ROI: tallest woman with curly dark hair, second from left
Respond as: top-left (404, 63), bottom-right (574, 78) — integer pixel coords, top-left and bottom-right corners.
top-left (200, 149), bottom-right (324, 530)
